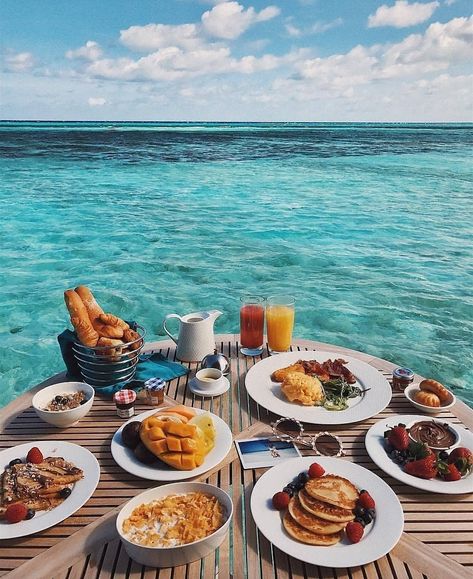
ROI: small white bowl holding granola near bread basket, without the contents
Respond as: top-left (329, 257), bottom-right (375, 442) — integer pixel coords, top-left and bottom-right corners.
top-left (32, 382), bottom-right (95, 428)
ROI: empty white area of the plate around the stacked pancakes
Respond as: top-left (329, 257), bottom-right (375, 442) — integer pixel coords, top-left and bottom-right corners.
top-left (251, 456), bottom-right (404, 567)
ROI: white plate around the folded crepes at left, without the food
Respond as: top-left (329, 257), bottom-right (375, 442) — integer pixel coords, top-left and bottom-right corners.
top-left (0, 440), bottom-right (100, 539)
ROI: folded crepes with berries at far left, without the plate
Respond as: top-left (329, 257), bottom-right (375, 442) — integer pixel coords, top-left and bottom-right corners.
top-left (0, 447), bottom-right (84, 523)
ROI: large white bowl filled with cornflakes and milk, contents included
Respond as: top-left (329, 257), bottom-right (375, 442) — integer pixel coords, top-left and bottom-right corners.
top-left (116, 482), bottom-right (233, 567)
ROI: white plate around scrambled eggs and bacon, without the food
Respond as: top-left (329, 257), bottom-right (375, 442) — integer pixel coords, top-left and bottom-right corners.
top-left (245, 351), bottom-right (392, 425)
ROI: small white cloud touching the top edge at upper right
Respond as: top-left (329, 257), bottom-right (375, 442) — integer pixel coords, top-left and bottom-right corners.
top-left (368, 0), bottom-right (440, 28)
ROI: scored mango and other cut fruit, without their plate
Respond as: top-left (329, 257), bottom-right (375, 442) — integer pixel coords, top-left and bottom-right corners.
top-left (122, 405), bottom-right (216, 470)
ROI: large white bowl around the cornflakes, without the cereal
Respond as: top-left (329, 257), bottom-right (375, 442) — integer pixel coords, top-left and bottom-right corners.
top-left (117, 482), bottom-right (233, 567)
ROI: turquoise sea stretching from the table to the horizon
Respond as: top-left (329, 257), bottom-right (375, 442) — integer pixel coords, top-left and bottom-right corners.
top-left (0, 122), bottom-right (473, 405)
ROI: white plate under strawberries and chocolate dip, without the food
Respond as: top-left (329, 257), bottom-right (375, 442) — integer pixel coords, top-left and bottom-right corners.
top-left (365, 415), bottom-right (473, 495)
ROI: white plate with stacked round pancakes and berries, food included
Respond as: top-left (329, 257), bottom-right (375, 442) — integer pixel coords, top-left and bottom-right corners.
top-left (250, 456), bottom-right (404, 567)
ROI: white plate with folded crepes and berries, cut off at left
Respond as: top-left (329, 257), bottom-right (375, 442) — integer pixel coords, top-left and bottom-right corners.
top-left (0, 440), bottom-right (100, 539)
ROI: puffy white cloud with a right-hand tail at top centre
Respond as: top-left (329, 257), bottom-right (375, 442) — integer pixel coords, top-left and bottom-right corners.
top-left (202, 2), bottom-right (280, 40)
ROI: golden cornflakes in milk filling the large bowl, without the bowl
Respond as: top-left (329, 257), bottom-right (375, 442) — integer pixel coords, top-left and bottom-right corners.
top-left (123, 492), bottom-right (225, 547)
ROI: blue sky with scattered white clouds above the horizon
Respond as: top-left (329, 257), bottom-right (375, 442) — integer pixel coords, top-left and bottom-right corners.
top-left (0, 0), bottom-right (473, 122)
